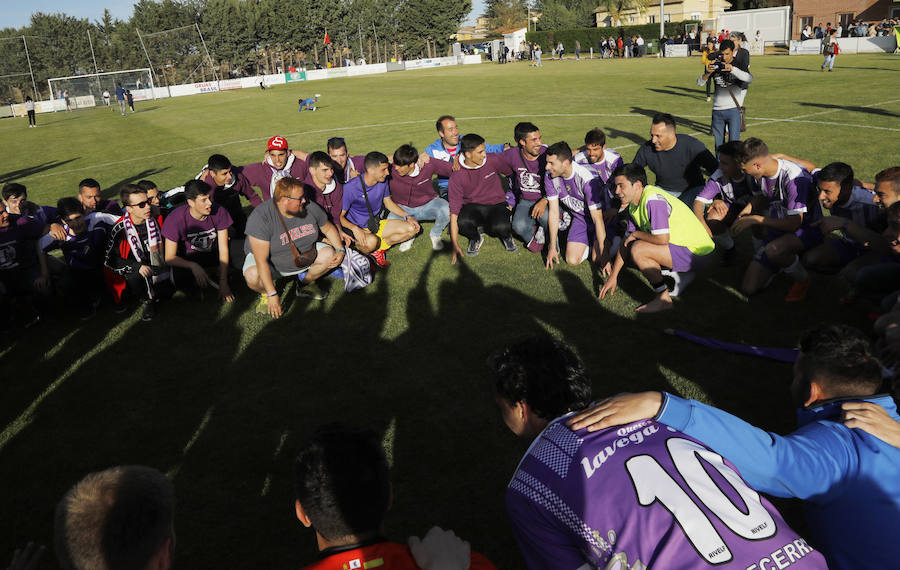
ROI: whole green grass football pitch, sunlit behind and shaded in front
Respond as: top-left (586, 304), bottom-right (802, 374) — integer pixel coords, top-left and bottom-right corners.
top-left (0, 54), bottom-right (900, 568)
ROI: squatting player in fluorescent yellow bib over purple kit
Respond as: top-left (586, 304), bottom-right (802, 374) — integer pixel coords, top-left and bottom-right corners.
top-left (600, 163), bottom-right (715, 313)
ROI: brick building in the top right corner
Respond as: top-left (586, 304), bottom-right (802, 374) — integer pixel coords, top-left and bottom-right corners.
top-left (791, 0), bottom-right (900, 40)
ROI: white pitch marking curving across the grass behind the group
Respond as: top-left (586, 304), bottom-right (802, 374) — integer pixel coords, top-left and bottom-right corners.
top-left (17, 99), bottom-right (900, 178)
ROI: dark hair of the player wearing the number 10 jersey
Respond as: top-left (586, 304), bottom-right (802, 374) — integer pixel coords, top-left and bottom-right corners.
top-left (489, 336), bottom-right (591, 420)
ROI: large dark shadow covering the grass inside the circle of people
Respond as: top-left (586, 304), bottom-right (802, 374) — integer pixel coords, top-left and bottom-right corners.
top-left (0, 239), bottom-right (836, 568)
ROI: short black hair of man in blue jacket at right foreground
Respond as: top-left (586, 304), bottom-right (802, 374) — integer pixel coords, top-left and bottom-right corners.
top-left (799, 325), bottom-right (882, 398)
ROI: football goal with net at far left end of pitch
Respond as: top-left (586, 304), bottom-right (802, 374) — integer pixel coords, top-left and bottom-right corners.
top-left (47, 67), bottom-right (154, 108)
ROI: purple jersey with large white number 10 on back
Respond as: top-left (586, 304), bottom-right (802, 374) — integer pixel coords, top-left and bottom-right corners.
top-left (506, 418), bottom-right (826, 570)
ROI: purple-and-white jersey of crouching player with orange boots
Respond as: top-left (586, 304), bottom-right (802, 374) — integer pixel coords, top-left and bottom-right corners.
top-left (753, 158), bottom-right (821, 225)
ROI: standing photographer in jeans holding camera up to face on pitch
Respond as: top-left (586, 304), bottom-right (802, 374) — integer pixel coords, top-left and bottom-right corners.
top-left (697, 40), bottom-right (753, 152)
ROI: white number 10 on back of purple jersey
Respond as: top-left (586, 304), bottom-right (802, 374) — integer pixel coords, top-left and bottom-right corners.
top-left (625, 437), bottom-right (777, 564)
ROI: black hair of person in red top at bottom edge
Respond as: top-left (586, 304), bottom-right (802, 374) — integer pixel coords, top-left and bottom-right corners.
top-left (294, 423), bottom-right (391, 540)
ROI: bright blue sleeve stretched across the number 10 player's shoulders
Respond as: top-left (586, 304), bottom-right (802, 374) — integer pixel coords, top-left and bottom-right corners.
top-left (656, 393), bottom-right (858, 501)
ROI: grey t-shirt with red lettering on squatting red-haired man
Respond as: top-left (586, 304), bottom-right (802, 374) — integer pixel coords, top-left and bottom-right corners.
top-left (244, 200), bottom-right (328, 273)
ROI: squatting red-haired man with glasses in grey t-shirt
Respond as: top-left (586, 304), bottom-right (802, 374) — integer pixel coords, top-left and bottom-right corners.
top-left (243, 178), bottom-right (344, 318)
